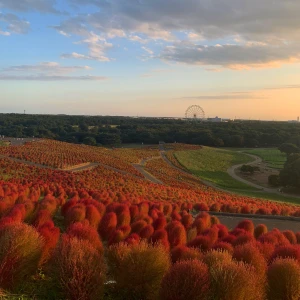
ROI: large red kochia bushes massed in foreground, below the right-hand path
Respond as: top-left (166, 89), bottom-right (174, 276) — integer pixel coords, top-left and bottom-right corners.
top-left (0, 182), bottom-right (300, 299)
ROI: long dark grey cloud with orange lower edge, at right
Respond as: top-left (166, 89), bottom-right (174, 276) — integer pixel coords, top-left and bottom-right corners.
top-left (159, 42), bottom-right (300, 70)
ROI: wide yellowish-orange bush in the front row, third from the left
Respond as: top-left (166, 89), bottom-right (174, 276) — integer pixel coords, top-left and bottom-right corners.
top-left (108, 241), bottom-right (170, 300)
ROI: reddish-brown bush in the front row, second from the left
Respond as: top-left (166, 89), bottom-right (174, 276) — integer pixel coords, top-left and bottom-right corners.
top-left (52, 234), bottom-right (106, 300)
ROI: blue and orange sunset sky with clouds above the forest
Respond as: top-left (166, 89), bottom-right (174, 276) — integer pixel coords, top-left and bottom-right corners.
top-left (0, 0), bottom-right (300, 120)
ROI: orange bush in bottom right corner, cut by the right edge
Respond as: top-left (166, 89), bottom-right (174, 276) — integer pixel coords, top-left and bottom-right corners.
top-left (267, 258), bottom-right (300, 300)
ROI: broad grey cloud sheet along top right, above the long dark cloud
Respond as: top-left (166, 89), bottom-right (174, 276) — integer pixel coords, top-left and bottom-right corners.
top-left (69, 0), bottom-right (300, 40)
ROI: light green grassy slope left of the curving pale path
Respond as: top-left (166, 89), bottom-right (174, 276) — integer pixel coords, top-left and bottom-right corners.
top-left (175, 147), bottom-right (257, 191)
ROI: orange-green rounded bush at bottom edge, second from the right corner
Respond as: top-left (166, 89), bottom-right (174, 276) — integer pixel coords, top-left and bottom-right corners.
top-left (210, 261), bottom-right (265, 300)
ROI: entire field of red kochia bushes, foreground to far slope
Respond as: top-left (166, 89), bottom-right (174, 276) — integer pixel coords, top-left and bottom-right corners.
top-left (0, 141), bottom-right (300, 300)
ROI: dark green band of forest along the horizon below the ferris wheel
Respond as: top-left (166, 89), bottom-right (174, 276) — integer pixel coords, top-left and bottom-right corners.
top-left (0, 114), bottom-right (300, 147)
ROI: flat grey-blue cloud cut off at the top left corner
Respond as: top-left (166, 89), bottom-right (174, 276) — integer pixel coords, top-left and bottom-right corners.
top-left (0, 0), bottom-right (58, 13)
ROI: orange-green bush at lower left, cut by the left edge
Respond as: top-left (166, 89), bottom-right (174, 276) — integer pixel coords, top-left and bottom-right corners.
top-left (0, 223), bottom-right (43, 291)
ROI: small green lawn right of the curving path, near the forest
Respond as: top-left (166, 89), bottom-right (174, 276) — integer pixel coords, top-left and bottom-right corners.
top-left (227, 148), bottom-right (286, 169)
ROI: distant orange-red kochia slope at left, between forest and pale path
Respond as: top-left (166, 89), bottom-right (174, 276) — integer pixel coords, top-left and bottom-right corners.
top-left (0, 140), bottom-right (159, 176)
